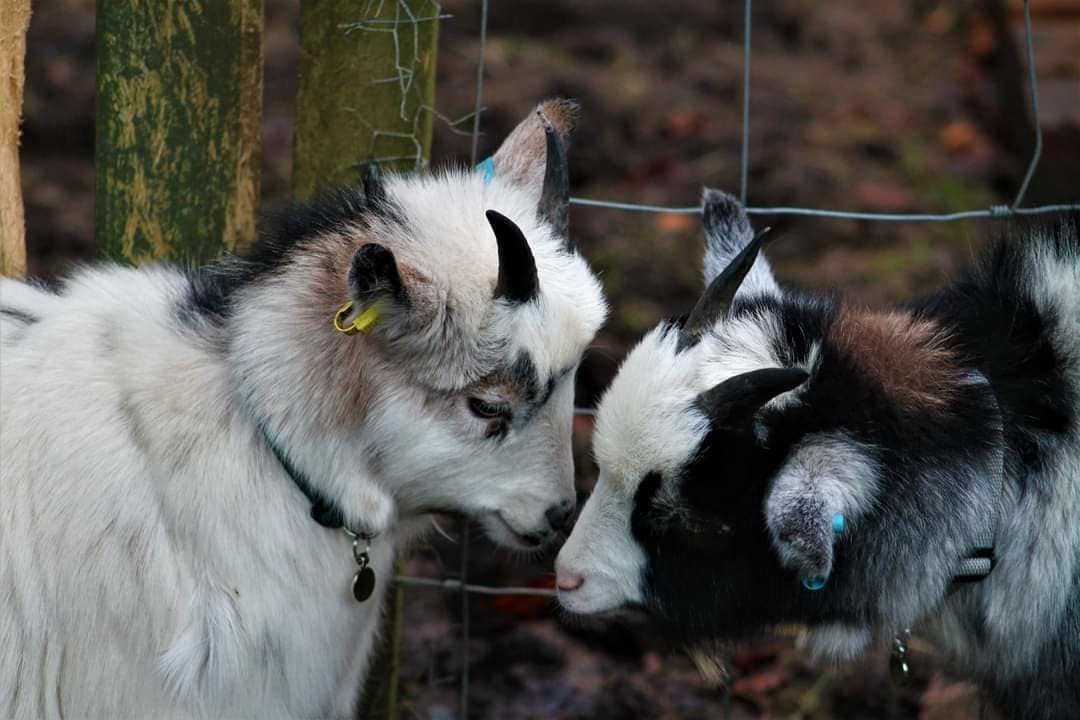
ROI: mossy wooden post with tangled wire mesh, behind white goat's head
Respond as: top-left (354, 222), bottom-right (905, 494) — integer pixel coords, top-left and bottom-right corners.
top-left (293, 0), bottom-right (440, 720)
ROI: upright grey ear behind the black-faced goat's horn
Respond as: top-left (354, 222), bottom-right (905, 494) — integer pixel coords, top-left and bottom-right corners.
top-left (701, 188), bottom-right (780, 295)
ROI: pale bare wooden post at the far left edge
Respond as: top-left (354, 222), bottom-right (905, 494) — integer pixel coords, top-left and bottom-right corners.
top-left (0, 0), bottom-right (30, 277)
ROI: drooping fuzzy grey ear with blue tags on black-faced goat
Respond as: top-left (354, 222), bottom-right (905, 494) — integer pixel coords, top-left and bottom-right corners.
top-left (765, 433), bottom-right (880, 589)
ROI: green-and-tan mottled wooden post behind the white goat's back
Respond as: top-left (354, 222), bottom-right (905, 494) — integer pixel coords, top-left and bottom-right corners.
top-left (95, 0), bottom-right (262, 263)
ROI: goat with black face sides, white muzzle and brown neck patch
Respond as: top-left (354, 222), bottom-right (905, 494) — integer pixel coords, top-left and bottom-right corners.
top-left (556, 191), bottom-right (1080, 718)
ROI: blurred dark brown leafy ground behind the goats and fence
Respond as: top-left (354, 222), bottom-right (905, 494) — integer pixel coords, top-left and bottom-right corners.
top-left (22, 0), bottom-right (1080, 720)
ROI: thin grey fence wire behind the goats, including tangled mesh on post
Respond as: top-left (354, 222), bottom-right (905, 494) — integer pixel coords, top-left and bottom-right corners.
top-left (365, 0), bottom-right (1080, 720)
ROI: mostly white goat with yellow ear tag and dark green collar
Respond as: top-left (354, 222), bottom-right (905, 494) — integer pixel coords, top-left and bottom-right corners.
top-left (0, 101), bottom-right (606, 718)
